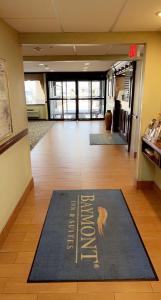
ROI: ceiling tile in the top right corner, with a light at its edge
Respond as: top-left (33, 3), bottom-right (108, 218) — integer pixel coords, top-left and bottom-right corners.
top-left (113, 0), bottom-right (161, 31)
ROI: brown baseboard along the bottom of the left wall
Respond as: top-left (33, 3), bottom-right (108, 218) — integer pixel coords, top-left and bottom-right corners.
top-left (0, 178), bottom-right (34, 246)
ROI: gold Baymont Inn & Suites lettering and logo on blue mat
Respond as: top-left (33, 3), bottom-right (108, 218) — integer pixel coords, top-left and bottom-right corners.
top-left (66, 195), bottom-right (108, 268)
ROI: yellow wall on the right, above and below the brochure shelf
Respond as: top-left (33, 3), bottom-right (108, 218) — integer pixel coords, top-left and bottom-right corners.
top-left (137, 33), bottom-right (161, 186)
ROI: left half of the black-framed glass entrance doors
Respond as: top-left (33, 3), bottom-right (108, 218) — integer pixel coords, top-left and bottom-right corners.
top-left (48, 81), bottom-right (76, 120)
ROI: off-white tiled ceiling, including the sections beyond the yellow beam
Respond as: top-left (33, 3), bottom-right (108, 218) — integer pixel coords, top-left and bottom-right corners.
top-left (0, 0), bottom-right (148, 72)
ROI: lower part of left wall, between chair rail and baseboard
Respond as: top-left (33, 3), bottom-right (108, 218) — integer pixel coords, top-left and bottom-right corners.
top-left (0, 137), bottom-right (31, 231)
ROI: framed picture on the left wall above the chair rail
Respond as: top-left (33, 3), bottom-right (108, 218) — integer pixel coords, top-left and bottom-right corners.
top-left (0, 59), bottom-right (12, 142)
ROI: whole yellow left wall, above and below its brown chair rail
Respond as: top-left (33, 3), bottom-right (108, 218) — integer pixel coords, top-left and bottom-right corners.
top-left (0, 20), bottom-right (32, 231)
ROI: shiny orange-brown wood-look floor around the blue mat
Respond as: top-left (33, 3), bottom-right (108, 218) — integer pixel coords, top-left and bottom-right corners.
top-left (0, 121), bottom-right (161, 300)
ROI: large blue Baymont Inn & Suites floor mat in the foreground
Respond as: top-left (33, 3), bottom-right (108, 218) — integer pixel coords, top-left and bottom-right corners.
top-left (28, 189), bottom-right (157, 282)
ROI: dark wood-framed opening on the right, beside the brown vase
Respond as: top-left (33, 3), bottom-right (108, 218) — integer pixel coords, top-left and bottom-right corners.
top-left (107, 61), bottom-right (136, 152)
